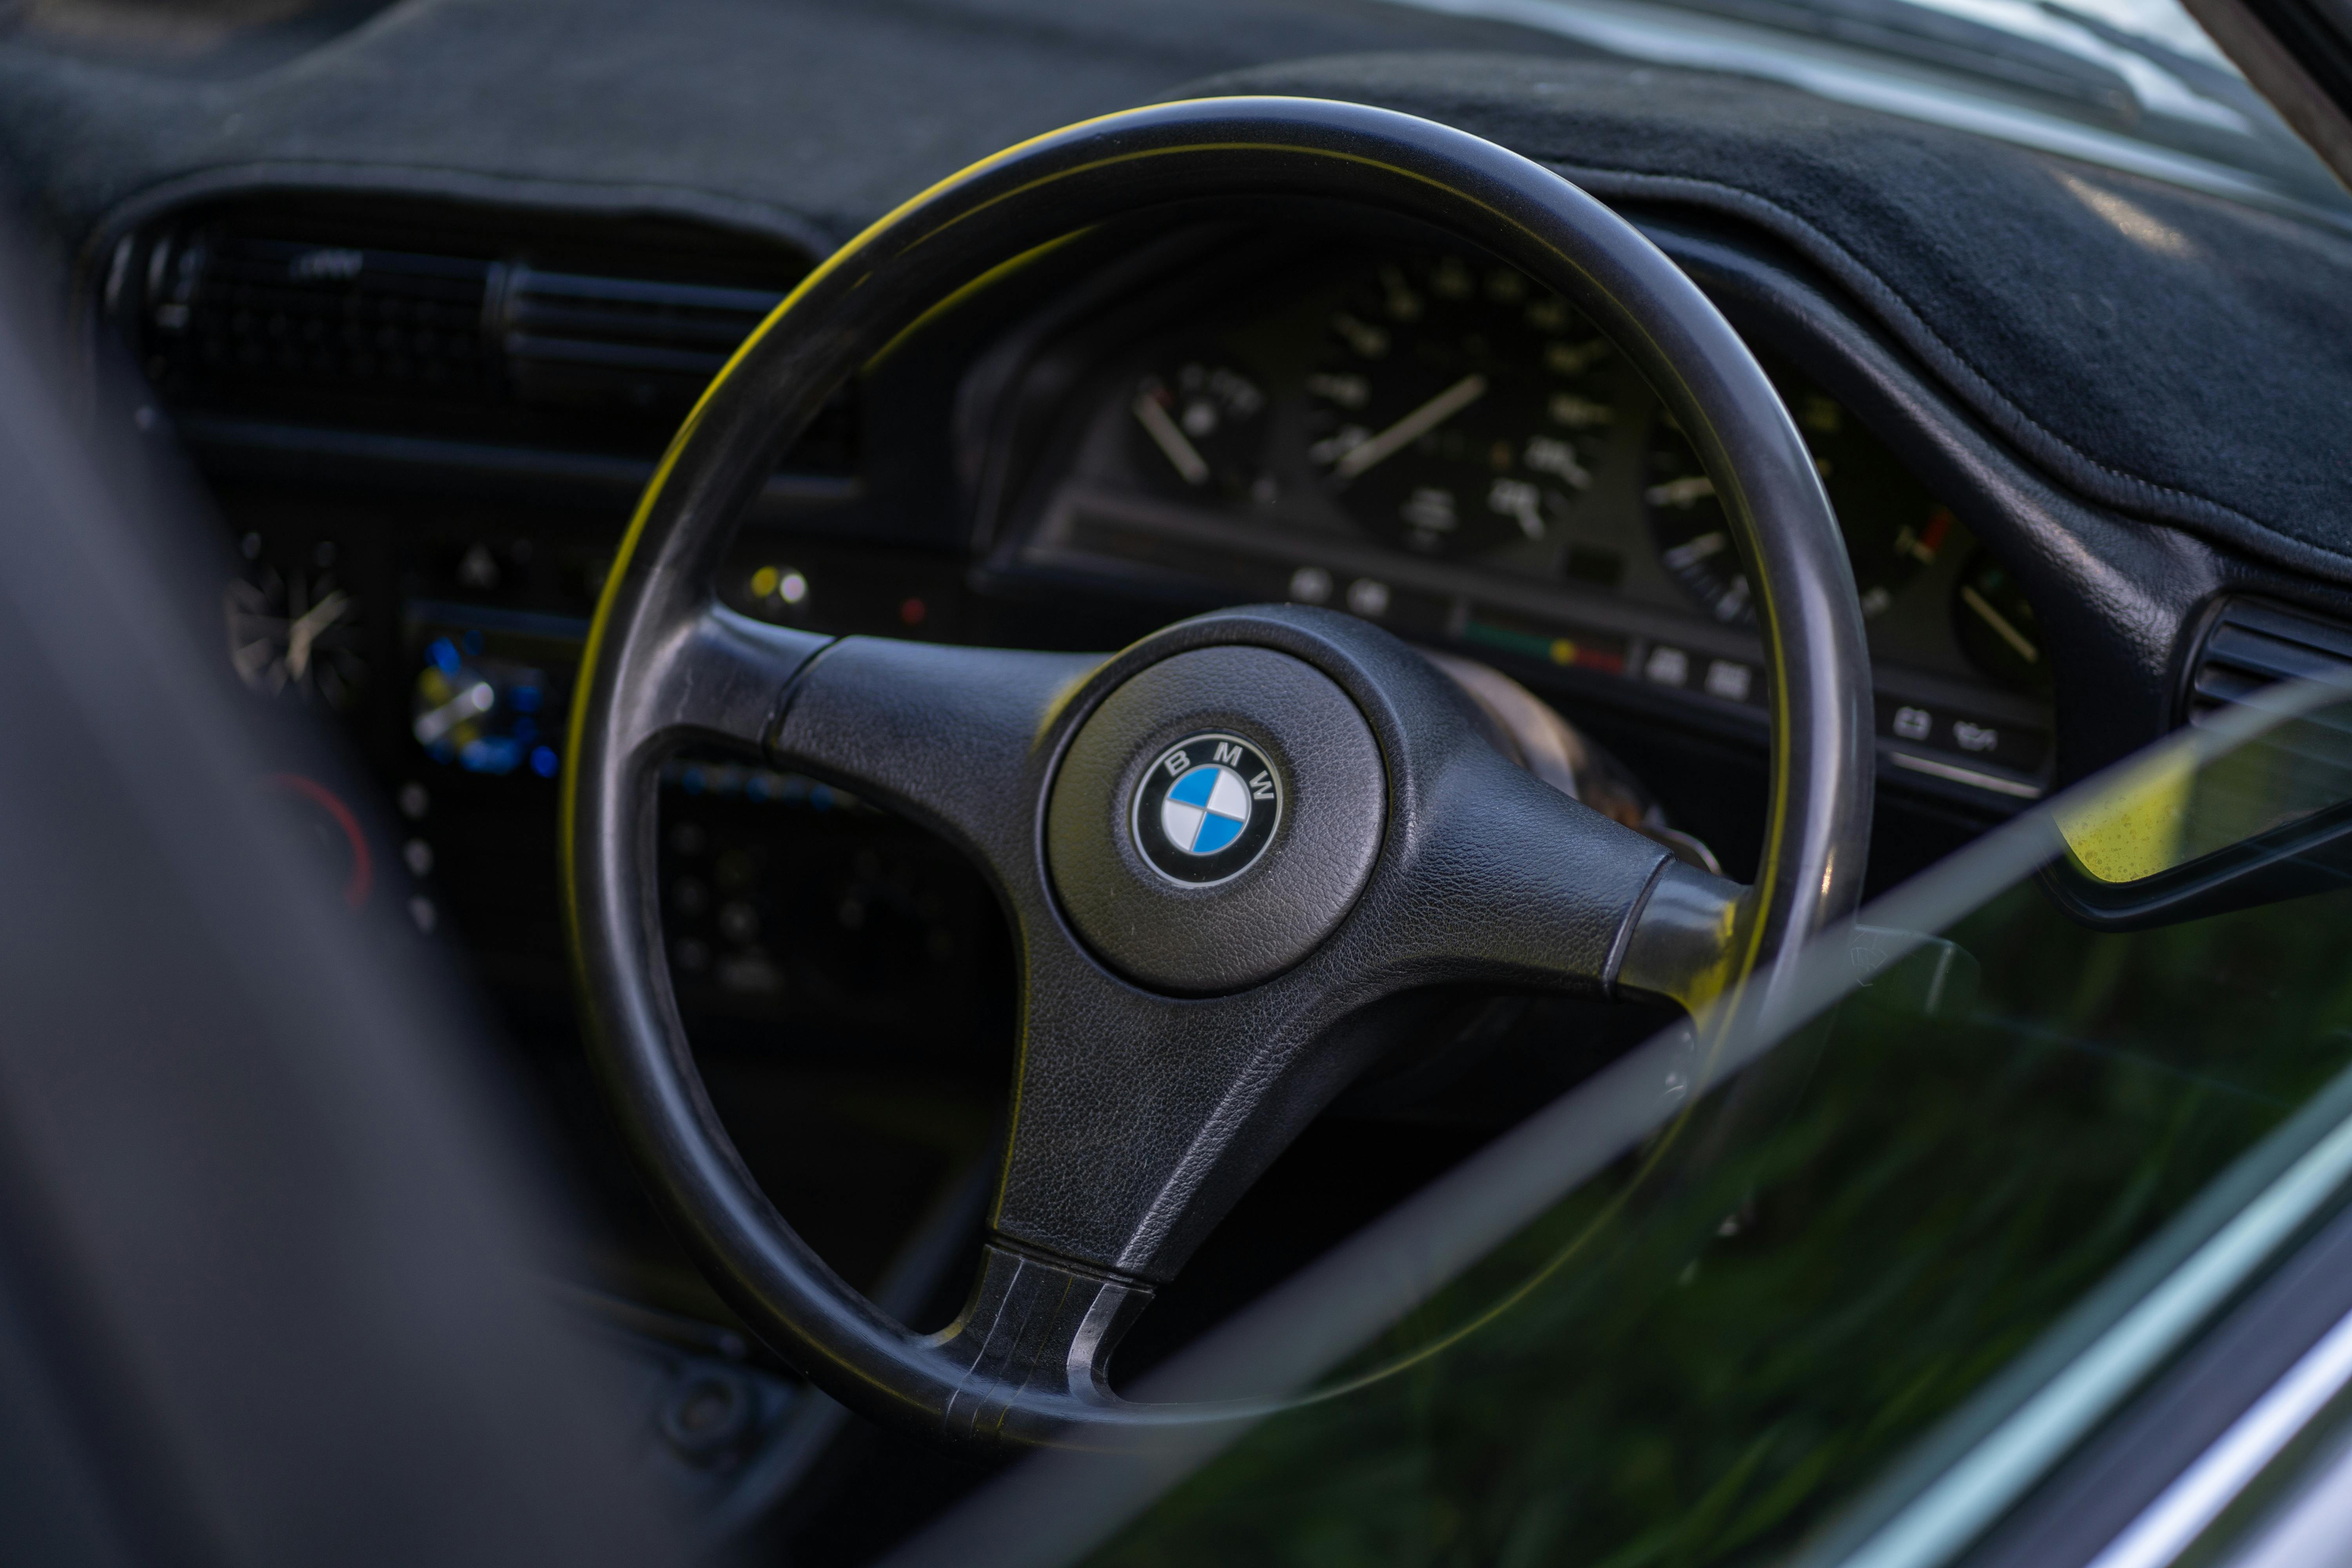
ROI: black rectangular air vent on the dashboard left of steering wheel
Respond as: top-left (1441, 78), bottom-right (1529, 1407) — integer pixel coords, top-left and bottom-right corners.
top-left (124, 207), bottom-right (854, 477)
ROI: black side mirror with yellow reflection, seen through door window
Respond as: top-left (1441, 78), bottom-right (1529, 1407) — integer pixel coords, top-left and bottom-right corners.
top-left (2042, 682), bottom-right (2352, 931)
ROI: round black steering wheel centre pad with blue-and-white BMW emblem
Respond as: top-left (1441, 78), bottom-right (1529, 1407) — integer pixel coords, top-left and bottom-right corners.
top-left (1047, 646), bottom-right (1388, 995)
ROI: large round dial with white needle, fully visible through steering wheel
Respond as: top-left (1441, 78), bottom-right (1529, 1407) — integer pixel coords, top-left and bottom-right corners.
top-left (1305, 256), bottom-right (1616, 555)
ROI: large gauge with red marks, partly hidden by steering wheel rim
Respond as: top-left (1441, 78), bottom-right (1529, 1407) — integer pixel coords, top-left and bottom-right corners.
top-left (1642, 369), bottom-right (1957, 625)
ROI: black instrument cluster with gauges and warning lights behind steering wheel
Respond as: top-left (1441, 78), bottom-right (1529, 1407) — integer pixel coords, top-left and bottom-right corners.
top-left (993, 245), bottom-right (2049, 802)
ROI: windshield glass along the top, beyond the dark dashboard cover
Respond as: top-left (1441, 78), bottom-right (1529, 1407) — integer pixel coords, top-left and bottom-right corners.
top-left (0, 0), bottom-right (2352, 228)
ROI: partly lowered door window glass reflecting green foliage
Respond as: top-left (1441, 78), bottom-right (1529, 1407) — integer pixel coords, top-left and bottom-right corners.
top-left (903, 689), bottom-right (2352, 1568)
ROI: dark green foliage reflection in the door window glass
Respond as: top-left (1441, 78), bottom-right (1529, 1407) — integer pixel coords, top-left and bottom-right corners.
top-left (1101, 886), bottom-right (2352, 1568)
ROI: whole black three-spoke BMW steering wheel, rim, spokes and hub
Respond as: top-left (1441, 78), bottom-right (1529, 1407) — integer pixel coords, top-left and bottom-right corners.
top-left (562, 99), bottom-right (1872, 1448)
